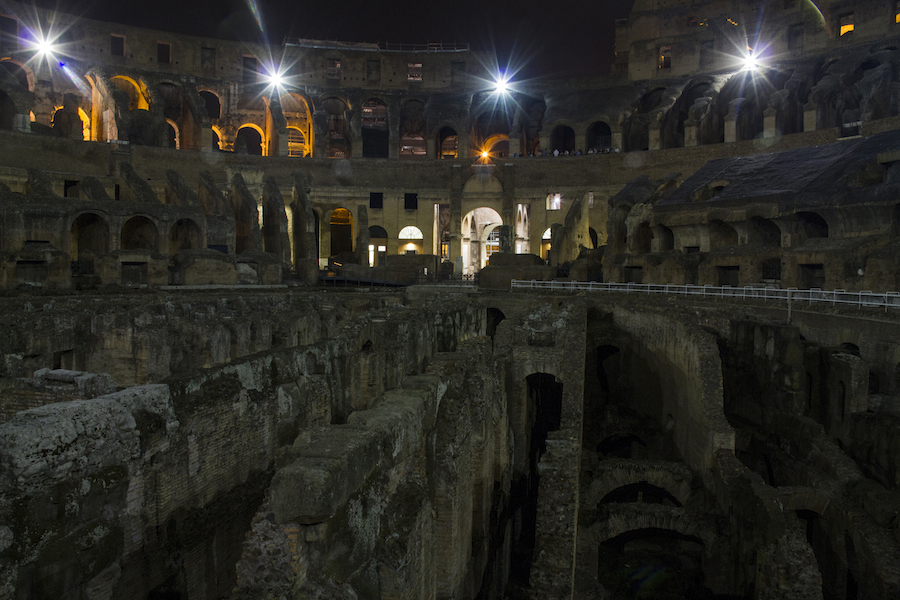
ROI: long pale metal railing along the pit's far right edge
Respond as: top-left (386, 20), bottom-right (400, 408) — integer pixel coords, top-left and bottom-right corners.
top-left (512, 279), bottom-right (900, 312)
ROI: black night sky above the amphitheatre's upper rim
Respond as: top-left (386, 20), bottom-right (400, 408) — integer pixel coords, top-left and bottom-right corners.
top-left (42, 0), bottom-right (633, 79)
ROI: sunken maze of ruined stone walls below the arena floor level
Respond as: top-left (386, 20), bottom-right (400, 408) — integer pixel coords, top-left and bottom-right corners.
top-left (0, 288), bottom-right (900, 599)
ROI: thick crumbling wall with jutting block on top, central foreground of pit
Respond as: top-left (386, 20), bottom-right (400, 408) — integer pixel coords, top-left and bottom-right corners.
top-left (234, 338), bottom-right (511, 600)
